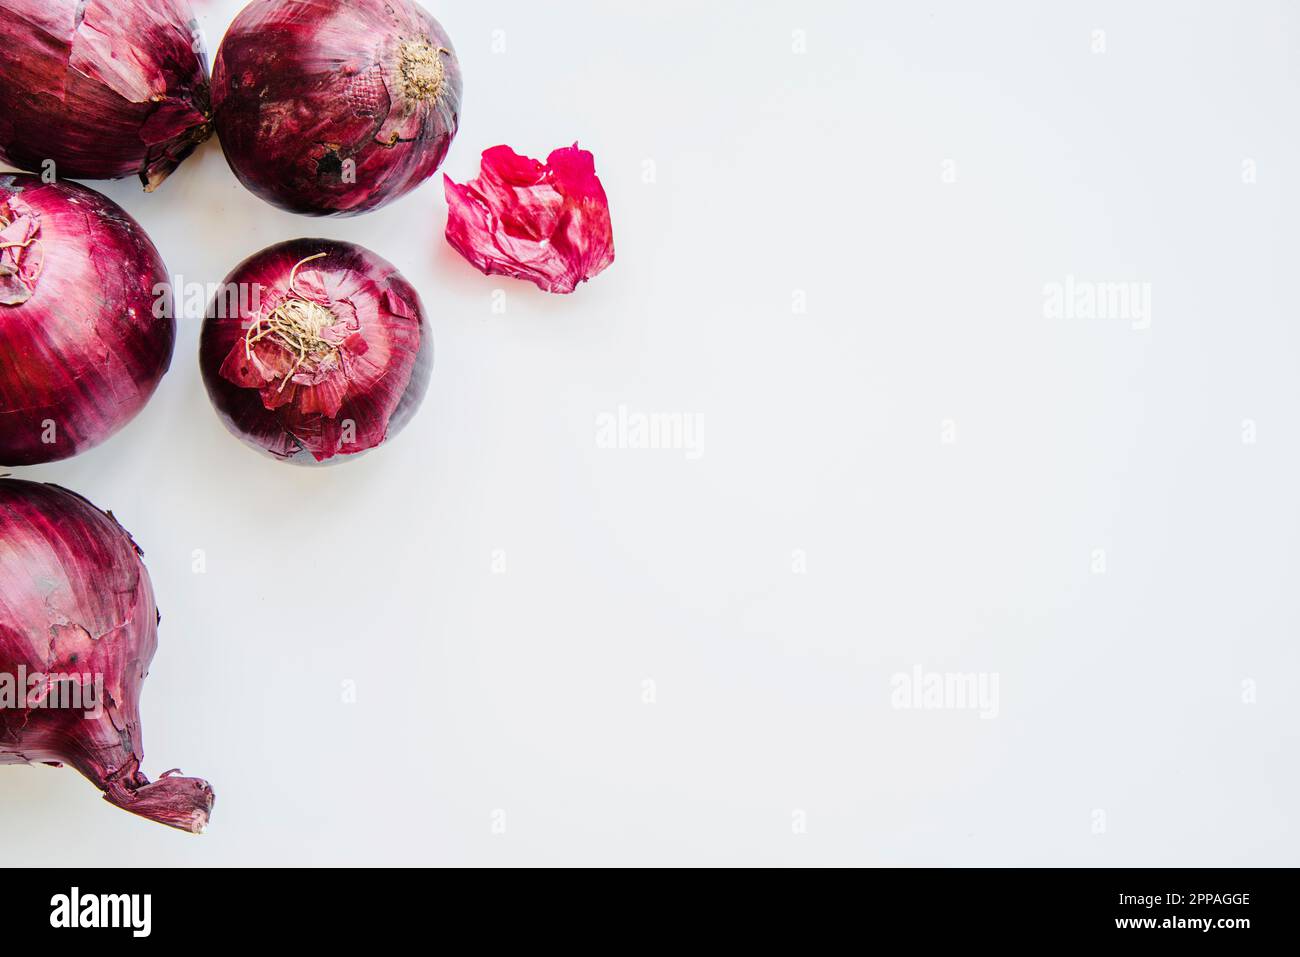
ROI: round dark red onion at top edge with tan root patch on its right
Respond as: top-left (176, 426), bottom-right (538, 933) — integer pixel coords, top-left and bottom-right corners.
top-left (212, 0), bottom-right (462, 216)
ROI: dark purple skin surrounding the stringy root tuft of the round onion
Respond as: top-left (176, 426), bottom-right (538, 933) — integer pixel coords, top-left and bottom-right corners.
top-left (199, 239), bottom-right (433, 465)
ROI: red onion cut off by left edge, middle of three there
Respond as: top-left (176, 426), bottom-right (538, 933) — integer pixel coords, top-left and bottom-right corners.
top-left (0, 174), bottom-right (176, 465)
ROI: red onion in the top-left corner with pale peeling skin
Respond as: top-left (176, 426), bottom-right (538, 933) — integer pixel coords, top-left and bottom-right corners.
top-left (0, 0), bottom-right (212, 191)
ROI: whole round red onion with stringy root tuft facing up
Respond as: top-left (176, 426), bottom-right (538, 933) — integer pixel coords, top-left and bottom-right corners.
top-left (199, 239), bottom-right (433, 464)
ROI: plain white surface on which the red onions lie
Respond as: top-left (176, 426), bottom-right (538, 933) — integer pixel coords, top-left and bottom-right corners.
top-left (0, 0), bottom-right (1300, 865)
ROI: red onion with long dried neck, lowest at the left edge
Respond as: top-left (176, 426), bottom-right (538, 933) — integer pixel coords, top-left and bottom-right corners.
top-left (0, 479), bottom-right (213, 833)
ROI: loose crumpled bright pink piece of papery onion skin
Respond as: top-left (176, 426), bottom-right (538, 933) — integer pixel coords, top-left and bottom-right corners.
top-left (443, 143), bottom-right (614, 293)
